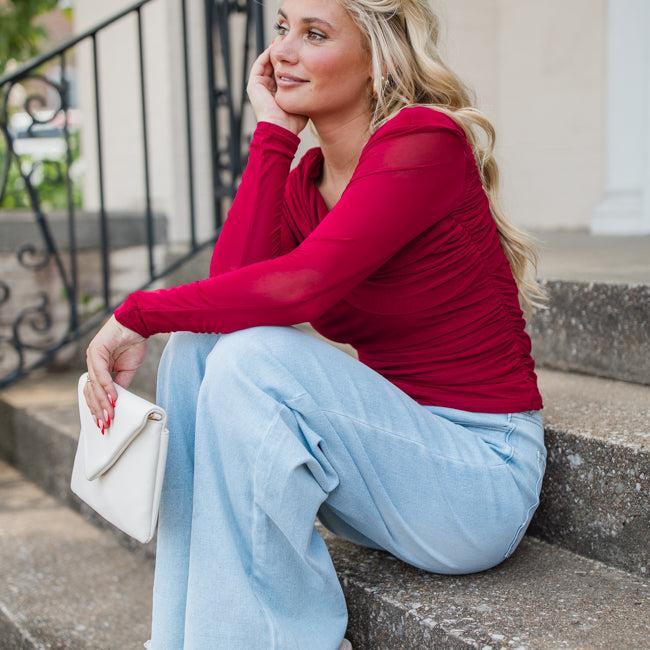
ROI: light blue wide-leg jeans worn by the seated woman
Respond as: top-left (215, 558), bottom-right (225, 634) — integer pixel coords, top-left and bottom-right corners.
top-left (145, 325), bottom-right (546, 650)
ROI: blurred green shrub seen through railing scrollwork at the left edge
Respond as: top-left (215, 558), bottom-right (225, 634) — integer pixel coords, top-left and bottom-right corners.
top-left (0, 131), bottom-right (82, 211)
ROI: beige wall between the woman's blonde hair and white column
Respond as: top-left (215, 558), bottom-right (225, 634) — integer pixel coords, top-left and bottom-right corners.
top-left (432, 0), bottom-right (606, 230)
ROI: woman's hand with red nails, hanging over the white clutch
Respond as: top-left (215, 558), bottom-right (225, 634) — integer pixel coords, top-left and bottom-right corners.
top-left (83, 315), bottom-right (147, 434)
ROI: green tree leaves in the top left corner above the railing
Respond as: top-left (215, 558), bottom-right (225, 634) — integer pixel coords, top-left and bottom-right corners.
top-left (0, 0), bottom-right (58, 74)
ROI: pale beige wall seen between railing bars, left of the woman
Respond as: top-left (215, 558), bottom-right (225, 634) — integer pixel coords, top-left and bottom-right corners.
top-left (74, 0), bottom-right (213, 241)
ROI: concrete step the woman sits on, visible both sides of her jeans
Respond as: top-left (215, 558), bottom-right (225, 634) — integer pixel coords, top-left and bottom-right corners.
top-left (0, 461), bottom-right (650, 650)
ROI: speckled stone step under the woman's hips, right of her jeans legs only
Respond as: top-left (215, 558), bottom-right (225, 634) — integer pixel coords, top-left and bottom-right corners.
top-left (324, 532), bottom-right (650, 650)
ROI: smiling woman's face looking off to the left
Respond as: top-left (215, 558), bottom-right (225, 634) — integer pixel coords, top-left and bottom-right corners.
top-left (270, 0), bottom-right (371, 119)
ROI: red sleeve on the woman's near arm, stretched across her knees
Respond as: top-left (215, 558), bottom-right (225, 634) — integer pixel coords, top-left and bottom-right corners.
top-left (115, 109), bottom-right (472, 336)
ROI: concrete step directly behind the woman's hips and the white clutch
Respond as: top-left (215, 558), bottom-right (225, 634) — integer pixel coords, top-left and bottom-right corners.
top-left (0, 362), bottom-right (650, 576)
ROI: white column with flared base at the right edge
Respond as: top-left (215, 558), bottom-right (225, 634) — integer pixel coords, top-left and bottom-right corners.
top-left (585, 0), bottom-right (650, 235)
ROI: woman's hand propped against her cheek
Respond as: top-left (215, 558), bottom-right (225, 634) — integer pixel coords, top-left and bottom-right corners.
top-left (246, 43), bottom-right (309, 135)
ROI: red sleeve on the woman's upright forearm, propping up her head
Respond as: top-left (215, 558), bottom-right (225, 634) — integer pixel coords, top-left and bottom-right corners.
top-left (209, 121), bottom-right (300, 277)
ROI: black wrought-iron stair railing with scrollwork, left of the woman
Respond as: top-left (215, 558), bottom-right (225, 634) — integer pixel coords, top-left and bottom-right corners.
top-left (0, 0), bottom-right (264, 388)
